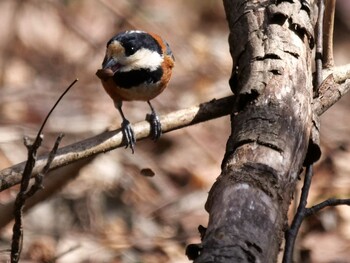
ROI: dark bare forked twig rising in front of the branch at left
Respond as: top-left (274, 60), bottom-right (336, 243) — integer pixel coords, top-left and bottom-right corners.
top-left (11, 80), bottom-right (78, 263)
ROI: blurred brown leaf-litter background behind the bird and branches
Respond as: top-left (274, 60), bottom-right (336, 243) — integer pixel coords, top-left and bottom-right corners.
top-left (0, 0), bottom-right (350, 263)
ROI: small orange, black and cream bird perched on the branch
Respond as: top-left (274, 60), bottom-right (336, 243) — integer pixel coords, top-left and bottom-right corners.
top-left (96, 31), bottom-right (175, 152)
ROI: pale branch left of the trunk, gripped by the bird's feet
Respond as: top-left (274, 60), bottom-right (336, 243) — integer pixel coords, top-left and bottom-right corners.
top-left (0, 96), bottom-right (234, 190)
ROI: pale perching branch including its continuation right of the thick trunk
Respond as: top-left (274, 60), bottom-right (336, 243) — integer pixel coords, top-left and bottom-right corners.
top-left (0, 65), bottom-right (350, 191)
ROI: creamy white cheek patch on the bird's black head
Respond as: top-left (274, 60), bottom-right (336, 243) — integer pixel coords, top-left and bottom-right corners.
top-left (120, 48), bottom-right (163, 72)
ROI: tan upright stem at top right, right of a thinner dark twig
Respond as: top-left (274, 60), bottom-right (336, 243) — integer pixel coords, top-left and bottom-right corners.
top-left (323, 0), bottom-right (336, 68)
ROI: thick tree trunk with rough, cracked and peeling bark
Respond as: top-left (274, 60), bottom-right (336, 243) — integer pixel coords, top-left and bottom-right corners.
top-left (195, 0), bottom-right (314, 263)
